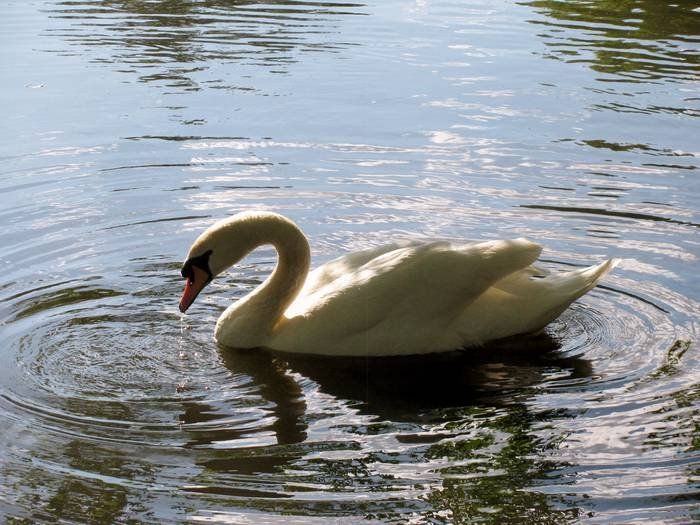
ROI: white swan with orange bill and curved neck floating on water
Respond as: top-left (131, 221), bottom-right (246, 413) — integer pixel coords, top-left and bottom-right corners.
top-left (180, 212), bottom-right (617, 356)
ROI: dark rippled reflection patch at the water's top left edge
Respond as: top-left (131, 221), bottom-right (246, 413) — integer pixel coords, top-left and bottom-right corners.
top-left (47, 0), bottom-right (365, 87)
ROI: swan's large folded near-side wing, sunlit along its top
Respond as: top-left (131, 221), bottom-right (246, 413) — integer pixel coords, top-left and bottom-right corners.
top-left (273, 239), bottom-right (541, 355)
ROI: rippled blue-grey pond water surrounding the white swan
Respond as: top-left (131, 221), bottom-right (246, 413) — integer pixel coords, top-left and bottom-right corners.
top-left (0, 0), bottom-right (700, 524)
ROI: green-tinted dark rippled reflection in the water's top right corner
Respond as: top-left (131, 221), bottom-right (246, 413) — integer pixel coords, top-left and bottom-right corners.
top-left (523, 0), bottom-right (700, 83)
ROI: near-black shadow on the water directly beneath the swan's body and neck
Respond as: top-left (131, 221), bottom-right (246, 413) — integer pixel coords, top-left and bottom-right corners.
top-left (221, 333), bottom-right (592, 422)
